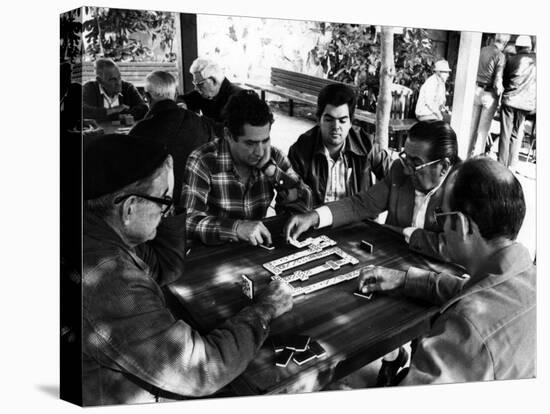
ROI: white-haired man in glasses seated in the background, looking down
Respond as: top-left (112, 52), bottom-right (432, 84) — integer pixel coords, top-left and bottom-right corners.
top-left (180, 58), bottom-right (242, 136)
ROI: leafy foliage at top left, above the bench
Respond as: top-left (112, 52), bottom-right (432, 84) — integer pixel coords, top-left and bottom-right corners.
top-left (61, 7), bottom-right (176, 62)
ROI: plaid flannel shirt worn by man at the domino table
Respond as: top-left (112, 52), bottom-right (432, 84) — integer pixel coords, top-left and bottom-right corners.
top-left (182, 138), bottom-right (312, 244)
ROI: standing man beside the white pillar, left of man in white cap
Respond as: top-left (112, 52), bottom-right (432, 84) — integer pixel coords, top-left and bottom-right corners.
top-left (468, 33), bottom-right (510, 157)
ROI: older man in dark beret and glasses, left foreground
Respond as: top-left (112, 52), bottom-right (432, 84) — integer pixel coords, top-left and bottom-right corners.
top-left (82, 135), bottom-right (292, 405)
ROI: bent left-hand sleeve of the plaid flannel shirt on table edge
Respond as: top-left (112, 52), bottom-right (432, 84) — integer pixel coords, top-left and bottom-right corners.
top-left (181, 153), bottom-right (239, 245)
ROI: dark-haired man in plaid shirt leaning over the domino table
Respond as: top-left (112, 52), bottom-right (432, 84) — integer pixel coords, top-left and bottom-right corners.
top-left (182, 90), bottom-right (312, 246)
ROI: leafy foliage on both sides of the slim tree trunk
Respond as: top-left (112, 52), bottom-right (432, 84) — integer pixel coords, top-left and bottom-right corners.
top-left (317, 23), bottom-right (436, 111)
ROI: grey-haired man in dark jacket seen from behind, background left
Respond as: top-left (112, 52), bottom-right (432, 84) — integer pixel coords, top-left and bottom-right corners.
top-left (130, 71), bottom-right (214, 207)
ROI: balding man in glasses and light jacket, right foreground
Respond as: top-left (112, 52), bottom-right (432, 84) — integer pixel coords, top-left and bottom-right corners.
top-left (359, 158), bottom-right (536, 385)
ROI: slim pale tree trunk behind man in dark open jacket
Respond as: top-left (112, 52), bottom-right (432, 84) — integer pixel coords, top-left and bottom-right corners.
top-left (374, 26), bottom-right (395, 150)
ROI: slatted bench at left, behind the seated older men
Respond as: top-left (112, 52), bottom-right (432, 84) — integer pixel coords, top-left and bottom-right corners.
top-left (72, 62), bottom-right (179, 89)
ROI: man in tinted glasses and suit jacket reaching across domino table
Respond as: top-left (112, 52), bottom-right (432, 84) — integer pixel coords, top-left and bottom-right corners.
top-left (285, 121), bottom-right (459, 258)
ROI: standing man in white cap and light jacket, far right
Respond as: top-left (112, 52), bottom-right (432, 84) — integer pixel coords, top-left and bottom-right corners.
top-left (498, 35), bottom-right (537, 171)
